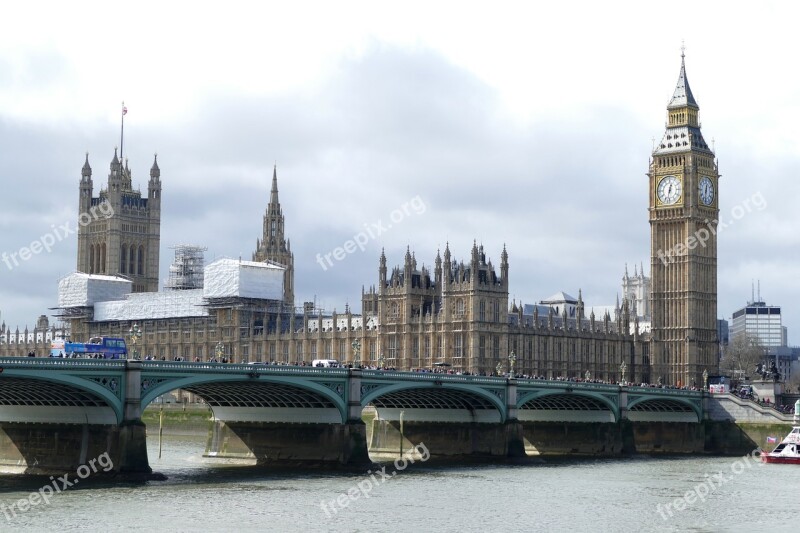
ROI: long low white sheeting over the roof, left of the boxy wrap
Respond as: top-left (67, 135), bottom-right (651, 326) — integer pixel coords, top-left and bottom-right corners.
top-left (93, 289), bottom-right (208, 322)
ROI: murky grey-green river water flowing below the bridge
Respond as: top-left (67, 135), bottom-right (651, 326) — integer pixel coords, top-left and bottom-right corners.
top-left (0, 436), bottom-right (800, 532)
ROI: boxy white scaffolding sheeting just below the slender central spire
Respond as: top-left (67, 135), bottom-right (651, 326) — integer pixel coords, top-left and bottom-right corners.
top-left (203, 259), bottom-right (285, 300)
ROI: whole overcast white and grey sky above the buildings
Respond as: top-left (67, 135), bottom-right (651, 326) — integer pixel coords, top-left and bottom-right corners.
top-left (0, 1), bottom-right (800, 342)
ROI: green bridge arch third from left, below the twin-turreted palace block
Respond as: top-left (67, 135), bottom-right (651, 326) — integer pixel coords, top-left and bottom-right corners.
top-left (361, 382), bottom-right (507, 422)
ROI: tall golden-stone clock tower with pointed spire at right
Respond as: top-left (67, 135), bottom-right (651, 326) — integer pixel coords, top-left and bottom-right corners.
top-left (648, 53), bottom-right (719, 387)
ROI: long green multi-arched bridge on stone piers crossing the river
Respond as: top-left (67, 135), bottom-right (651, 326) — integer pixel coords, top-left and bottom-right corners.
top-left (0, 358), bottom-right (756, 472)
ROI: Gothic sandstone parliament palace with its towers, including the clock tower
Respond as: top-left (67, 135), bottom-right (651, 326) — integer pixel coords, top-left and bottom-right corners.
top-left (0, 55), bottom-right (719, 386)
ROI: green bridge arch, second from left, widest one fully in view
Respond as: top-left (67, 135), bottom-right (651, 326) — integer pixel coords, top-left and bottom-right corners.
top-left (141, 374), bottom-right (347, 423)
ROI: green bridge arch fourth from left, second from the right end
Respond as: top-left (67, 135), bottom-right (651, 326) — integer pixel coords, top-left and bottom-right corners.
top-left (517, 389), bottom-right (620, 422)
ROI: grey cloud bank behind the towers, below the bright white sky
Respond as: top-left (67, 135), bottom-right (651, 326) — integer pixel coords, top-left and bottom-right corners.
top-left (0, 46), bottom-right (800, 340)
